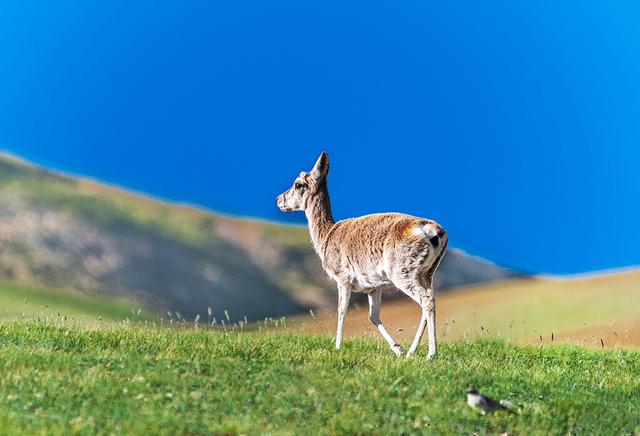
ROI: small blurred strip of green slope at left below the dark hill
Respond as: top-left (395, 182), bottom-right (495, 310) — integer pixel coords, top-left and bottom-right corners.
top-left (0, 283), bottom-right (154, 323)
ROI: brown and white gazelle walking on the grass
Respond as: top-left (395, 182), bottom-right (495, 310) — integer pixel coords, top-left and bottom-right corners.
top-left (278, 152), bottom-right (448, 359)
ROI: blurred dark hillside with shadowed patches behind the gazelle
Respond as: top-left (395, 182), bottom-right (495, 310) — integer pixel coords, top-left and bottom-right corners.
top-left (0, 155), bottom-right (513, 319)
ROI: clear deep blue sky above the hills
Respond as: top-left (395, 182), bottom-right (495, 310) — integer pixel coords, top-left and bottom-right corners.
top-left (0, 0), bottom-right (640, 273)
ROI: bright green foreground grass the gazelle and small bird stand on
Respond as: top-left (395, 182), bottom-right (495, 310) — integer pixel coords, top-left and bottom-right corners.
top-left (0, 322), bottom-right (640, 434)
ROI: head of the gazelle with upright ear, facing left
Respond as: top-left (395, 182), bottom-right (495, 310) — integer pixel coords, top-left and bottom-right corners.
top-left (278, 151), bottom-right (329, 212)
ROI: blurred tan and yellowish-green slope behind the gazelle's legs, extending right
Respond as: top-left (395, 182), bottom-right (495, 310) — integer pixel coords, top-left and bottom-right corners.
top-left (289, 270), bottom-right (640, 347)
